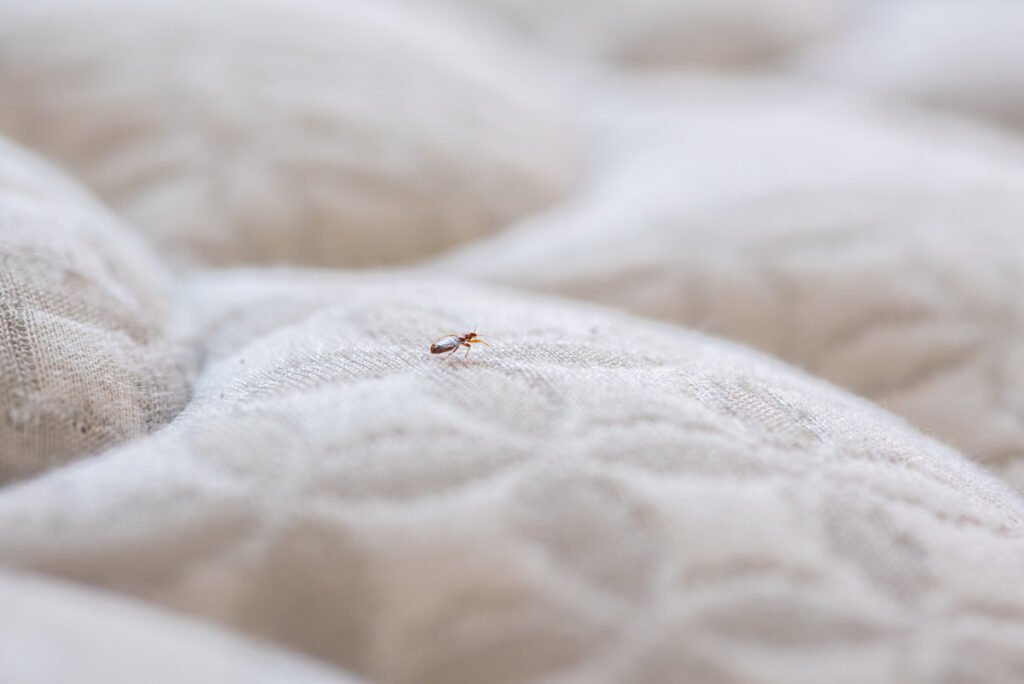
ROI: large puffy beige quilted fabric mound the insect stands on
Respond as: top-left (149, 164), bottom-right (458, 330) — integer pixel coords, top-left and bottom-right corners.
top-left (0, 272), bottom-right (1024, 683)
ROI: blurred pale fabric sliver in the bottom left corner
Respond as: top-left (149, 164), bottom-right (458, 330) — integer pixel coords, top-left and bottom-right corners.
top-left (0, 572), bottom-right (362, 684)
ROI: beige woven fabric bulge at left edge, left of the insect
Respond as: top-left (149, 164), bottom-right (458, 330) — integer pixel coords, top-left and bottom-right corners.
top-left (0, 140), bottom-right (193, 483)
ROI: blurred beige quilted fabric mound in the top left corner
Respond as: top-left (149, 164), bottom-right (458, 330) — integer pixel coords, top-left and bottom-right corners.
top-left (0, 0), bottom-right (579, 266)
